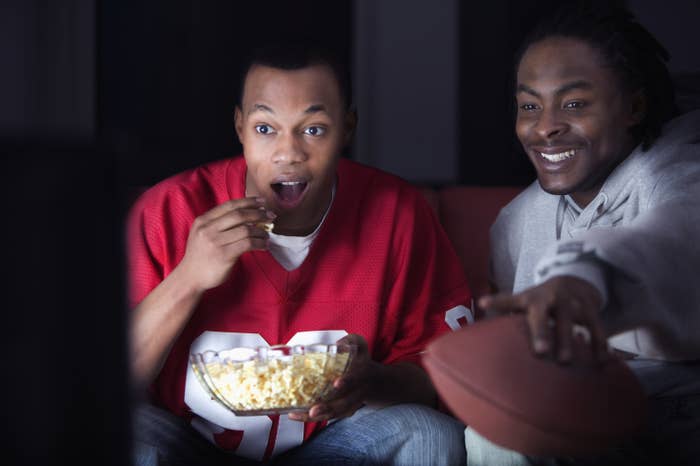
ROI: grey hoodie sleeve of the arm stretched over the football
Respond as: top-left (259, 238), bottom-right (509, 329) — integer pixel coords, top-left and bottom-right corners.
top-left (535, 149), bottom-right (700, 360)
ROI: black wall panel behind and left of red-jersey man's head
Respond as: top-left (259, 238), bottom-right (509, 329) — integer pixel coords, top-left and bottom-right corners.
top-left (99, 0), bottom-right (352, 186)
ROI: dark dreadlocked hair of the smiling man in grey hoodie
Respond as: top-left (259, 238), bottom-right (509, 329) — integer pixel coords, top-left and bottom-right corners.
top-left (515, 0), bottom-right (677, 150)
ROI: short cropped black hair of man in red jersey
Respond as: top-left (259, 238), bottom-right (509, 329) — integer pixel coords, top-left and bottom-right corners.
top-left (236, 39), bottom-right (353, 110)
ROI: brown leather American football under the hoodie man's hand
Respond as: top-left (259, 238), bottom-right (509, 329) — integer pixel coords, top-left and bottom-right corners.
top-left (423, 315), bottom-right (646, 456)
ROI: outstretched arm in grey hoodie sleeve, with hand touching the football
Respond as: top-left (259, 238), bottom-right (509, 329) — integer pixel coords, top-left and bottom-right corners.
top-left (481, 160), bottom-right (700, 360)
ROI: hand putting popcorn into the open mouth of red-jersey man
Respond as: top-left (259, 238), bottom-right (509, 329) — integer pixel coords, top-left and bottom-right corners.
top-left (177, 197), bottom-right (276, 292)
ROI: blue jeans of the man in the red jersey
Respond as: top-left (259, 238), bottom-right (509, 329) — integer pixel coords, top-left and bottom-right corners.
top-left (134, 404), bottom-right (466, 466)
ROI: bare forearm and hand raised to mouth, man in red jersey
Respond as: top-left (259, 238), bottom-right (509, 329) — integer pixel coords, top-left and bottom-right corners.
top-left (130, 198), bottom-right (274, 384)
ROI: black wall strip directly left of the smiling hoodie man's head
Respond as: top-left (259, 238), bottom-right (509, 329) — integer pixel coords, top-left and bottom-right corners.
top-left (459, 0), bottom-right (560, 186)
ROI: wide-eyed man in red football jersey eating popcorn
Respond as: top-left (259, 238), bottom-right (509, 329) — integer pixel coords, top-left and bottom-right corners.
top-left (128, 41), bottom-right (471, 464)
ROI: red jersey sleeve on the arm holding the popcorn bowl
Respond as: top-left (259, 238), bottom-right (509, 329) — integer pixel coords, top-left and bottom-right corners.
top-left (383, 187), bottom-right (471, 364)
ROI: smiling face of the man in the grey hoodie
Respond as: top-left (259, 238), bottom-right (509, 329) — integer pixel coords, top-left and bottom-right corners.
top-left (515, 37), bottom-right (643, 207)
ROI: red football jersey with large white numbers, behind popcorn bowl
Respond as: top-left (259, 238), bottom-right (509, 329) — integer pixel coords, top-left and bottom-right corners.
top-left (128, 157), bottom-right (470, 460)
